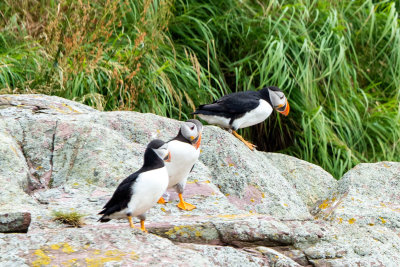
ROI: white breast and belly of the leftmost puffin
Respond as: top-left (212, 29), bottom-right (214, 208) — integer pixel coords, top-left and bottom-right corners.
top-left (128, 167), bottom-right (168, 216)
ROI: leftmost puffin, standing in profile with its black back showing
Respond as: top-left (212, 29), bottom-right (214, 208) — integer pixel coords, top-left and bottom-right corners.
top-left (99, 139), bottom-right (171, 232)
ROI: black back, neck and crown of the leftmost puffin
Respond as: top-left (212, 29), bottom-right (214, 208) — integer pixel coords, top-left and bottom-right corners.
top-left (99, 139), bottom-right (165, 222)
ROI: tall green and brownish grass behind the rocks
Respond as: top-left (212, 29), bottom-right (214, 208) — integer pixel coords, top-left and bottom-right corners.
top-left (0, 0), bottom-right (400, 178)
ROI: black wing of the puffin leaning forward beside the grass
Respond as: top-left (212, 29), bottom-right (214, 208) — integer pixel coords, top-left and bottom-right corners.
top-left (194, 91), bottom-right (261, 115)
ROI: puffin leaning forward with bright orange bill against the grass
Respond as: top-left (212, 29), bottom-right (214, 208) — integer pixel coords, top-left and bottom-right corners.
top-left (193, 86), bottom-right (290, 150)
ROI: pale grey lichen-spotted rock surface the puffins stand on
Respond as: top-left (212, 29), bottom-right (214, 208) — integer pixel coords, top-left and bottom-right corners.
top-left (0, 95), bottom-right (400, 266)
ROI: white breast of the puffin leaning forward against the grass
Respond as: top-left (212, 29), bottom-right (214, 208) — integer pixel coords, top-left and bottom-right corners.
top-left (232, 99), bottom-right (273, 129)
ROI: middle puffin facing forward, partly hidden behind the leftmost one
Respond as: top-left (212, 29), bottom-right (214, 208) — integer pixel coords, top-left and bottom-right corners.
top-left (158, 120), bottom-right (203, 210)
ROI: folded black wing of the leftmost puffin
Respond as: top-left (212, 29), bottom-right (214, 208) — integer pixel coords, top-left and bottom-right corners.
top-left (99, 172), bottom-right (139, 221)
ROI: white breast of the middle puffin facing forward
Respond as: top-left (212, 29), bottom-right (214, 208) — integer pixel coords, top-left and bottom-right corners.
top-left (165, 140), bottom-right (200, 188)
